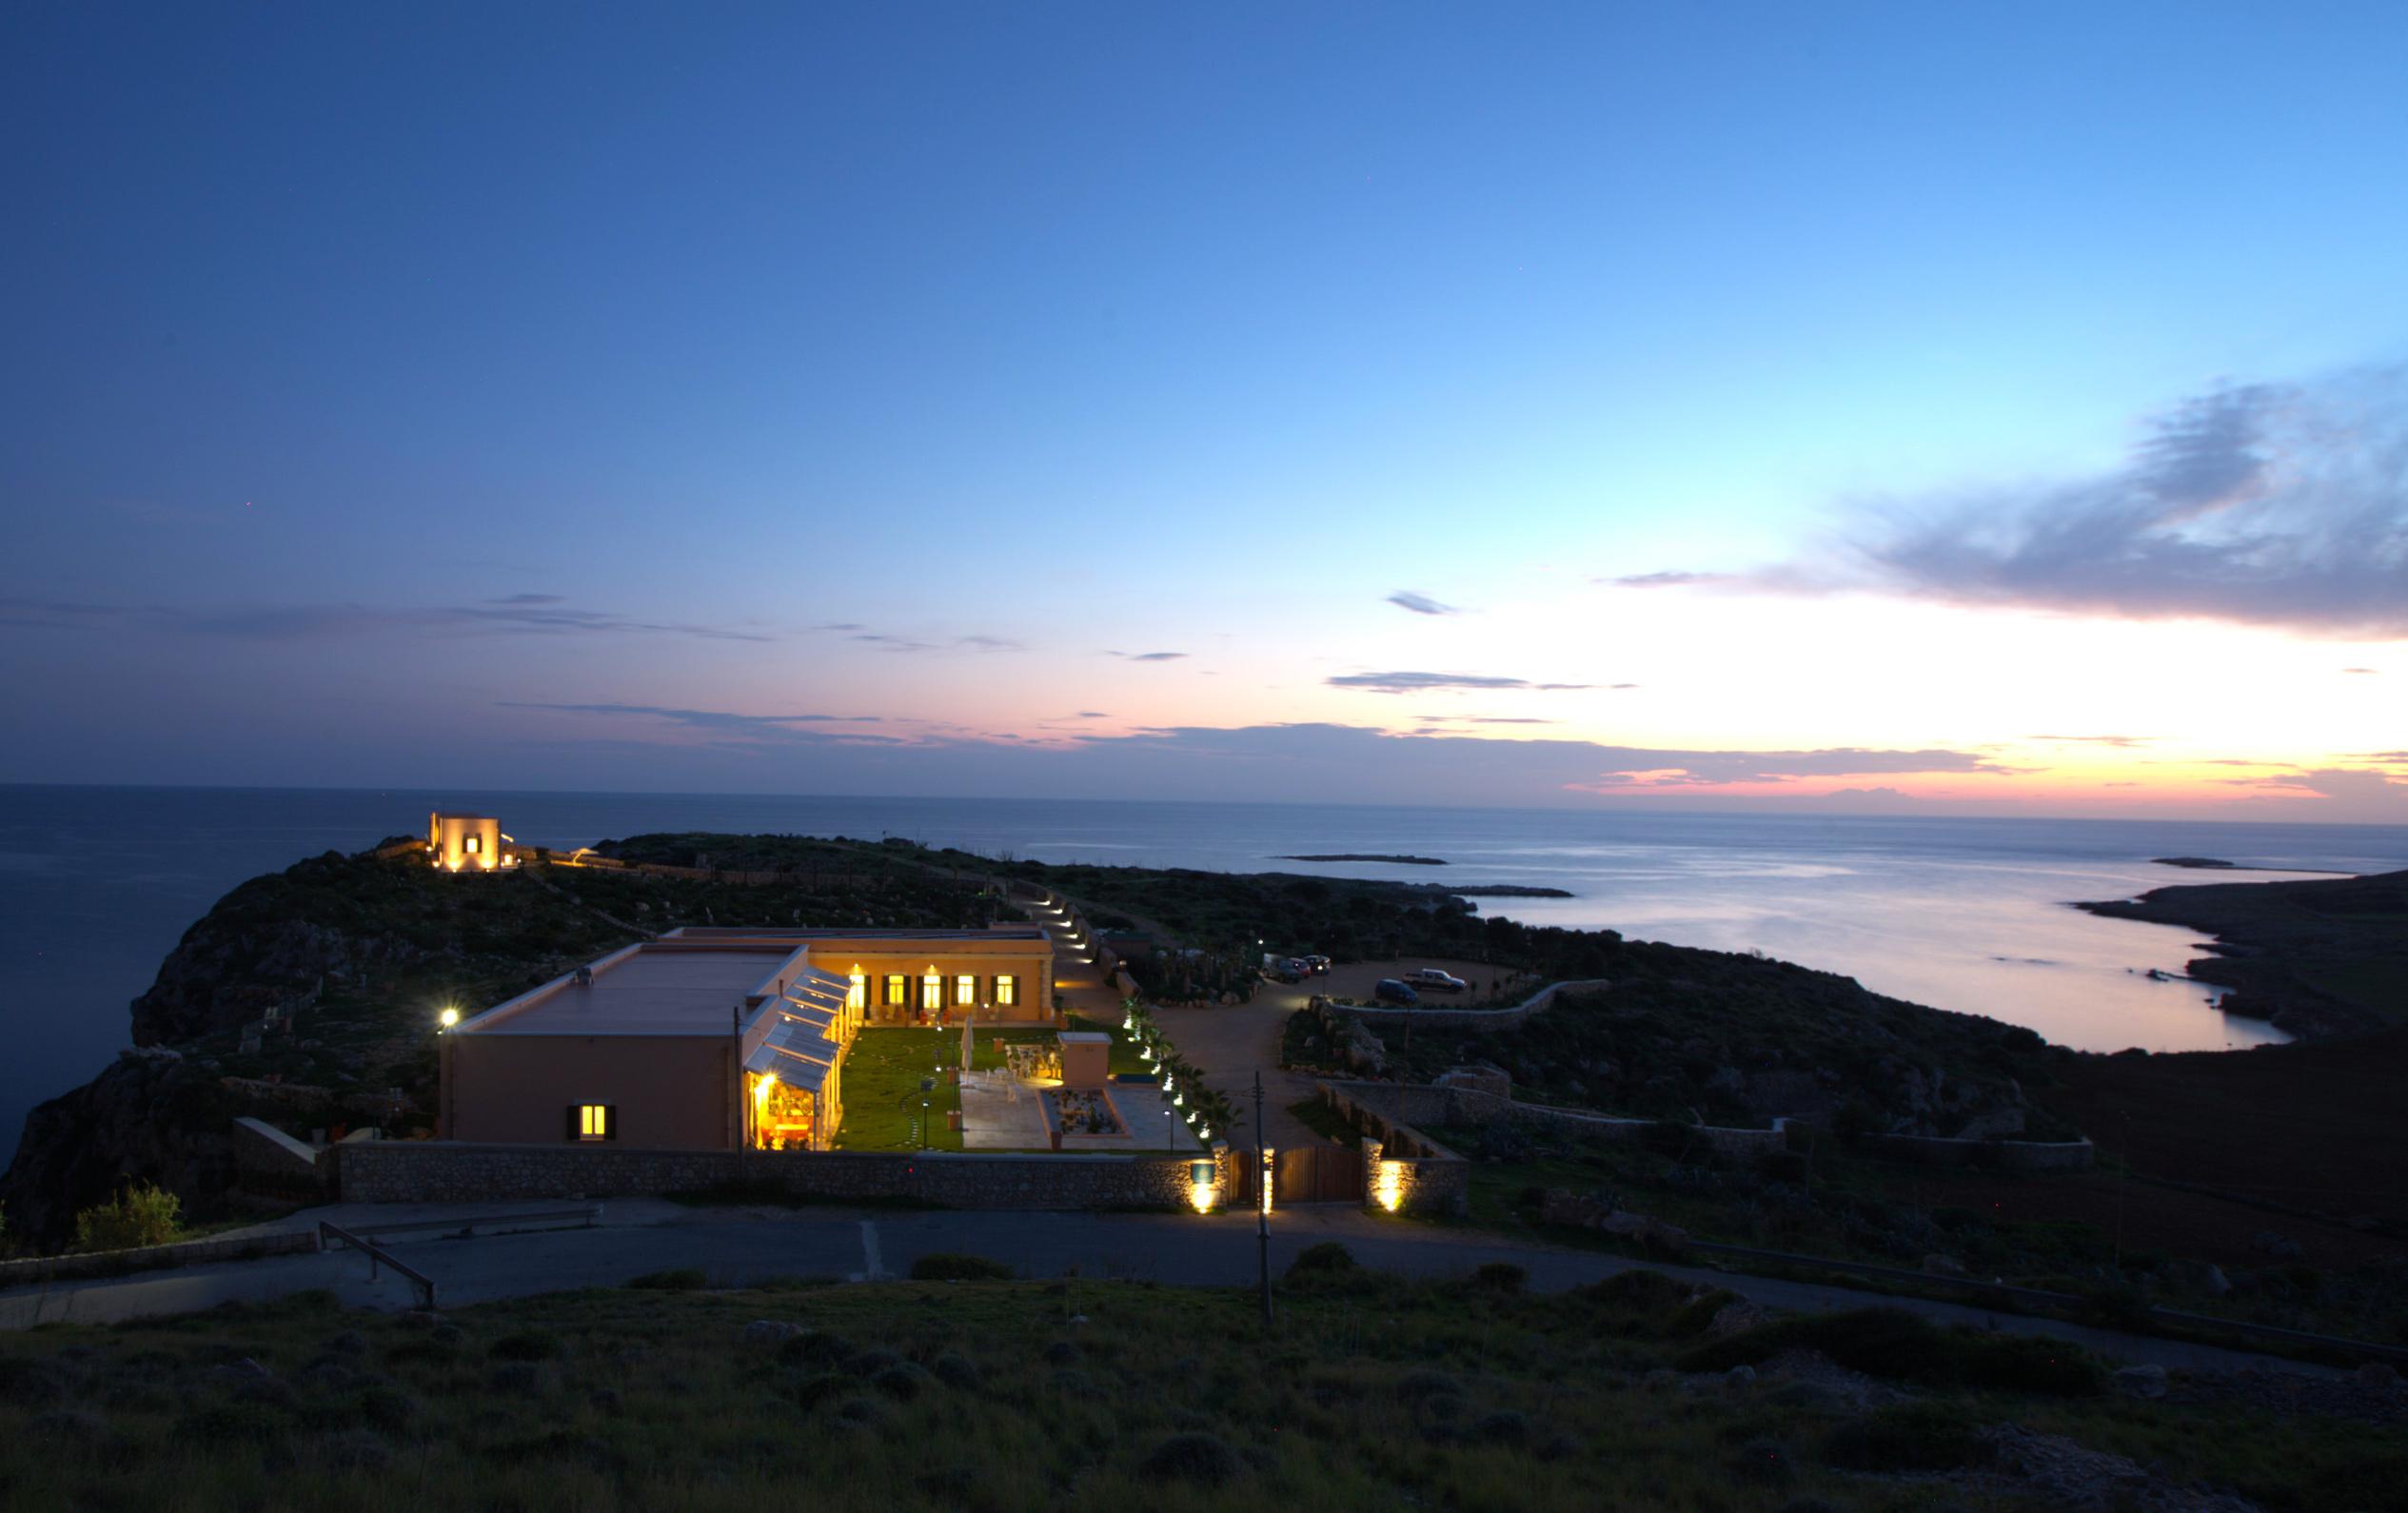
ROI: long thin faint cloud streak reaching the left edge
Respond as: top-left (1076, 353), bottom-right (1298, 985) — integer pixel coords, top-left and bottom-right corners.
top-left (0, 595), bottom-right (773, 640)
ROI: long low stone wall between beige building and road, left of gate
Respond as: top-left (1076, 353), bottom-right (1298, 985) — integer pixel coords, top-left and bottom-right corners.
top-left (335, 1140), bottom-right (1231, 1209)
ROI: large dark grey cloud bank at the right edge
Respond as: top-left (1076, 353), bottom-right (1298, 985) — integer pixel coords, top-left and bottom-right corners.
top-left (1820, 368), bottom-right (2408, 639)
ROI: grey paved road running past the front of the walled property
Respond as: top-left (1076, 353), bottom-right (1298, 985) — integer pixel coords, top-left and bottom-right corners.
top-left (0, 1200), bottom-right (2334, 1376)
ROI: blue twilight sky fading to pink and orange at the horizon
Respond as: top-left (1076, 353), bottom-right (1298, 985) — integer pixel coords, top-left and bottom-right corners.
top-left (0, 0), bottom-right (2408, 819)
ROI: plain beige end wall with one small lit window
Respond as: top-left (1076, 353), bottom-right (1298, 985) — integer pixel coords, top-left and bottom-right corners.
top-left (444, 1033), bottom-right (741, 1149)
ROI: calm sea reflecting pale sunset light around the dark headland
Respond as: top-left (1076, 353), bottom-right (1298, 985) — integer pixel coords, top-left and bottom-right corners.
top-left (0, 785), bottom-right (2408, 1159)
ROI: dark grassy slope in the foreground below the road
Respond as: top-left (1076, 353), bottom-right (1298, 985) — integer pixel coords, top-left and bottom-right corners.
top-left (0, 1265), bottom-right (2398, 1513)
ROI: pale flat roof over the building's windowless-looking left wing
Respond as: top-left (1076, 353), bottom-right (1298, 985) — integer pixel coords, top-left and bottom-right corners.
top-left (450, 942), bottom-right (799, 1036)
